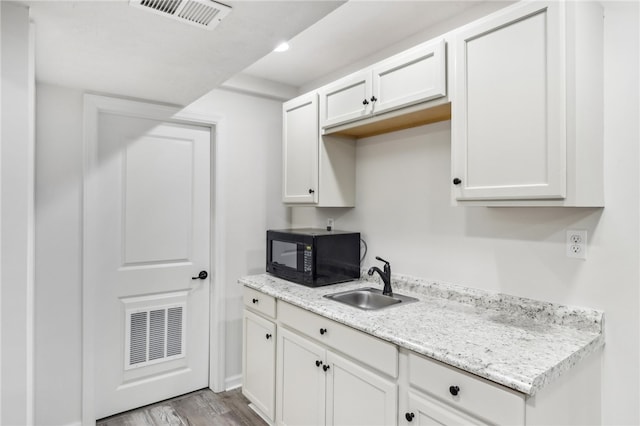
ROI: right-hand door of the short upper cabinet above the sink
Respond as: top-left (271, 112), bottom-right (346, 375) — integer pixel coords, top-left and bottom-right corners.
top-left (373, 39), bottom-right (447, 114)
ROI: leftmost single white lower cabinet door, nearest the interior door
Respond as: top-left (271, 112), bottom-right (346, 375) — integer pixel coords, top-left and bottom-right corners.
top-left (242, 310), bottom-right (276, 421)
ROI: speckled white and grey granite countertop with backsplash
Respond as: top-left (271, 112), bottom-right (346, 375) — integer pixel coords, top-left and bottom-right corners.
top-left (238, 274), bottom-right (604, 395)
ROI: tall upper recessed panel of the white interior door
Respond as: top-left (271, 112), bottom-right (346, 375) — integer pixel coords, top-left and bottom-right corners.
top-left (123, 136), bottom-right (194, 265)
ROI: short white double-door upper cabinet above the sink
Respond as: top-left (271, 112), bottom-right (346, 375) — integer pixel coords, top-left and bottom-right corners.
top-left (319, 39), bottom-right (447, 129)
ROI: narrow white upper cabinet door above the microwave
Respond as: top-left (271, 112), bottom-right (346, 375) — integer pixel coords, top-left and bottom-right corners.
top-left (282, 93), bottom-right (319, 203)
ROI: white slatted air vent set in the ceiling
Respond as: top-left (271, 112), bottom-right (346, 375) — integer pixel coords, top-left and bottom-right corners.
top-left (129, 0), bottom-right (231, 30)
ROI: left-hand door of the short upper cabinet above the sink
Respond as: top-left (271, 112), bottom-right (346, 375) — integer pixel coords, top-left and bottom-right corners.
top-left (320, 69), bottom-right (372, 128)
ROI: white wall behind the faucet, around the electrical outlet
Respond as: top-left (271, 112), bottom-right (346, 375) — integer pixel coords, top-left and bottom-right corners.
top-left (292, 2), bottom-right (640, 425)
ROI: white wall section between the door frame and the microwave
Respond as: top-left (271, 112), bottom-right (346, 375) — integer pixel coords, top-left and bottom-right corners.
top-left (186, 90), bottom-right (288, 387)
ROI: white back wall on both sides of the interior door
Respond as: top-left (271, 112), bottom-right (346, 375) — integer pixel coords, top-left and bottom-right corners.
top-left (35, 84), bottom-right (287, 425)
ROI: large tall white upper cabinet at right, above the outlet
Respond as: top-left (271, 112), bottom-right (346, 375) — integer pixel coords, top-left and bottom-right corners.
top-left (452, 1), bottom-right (603, 206)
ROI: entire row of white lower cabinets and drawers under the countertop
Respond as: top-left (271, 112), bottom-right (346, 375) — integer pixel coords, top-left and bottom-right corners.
top-left (243, 288), bottom-right (601, 426)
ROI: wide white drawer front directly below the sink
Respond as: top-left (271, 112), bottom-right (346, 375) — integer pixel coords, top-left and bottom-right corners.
top-left (278, 303), bottom-right (398, 377)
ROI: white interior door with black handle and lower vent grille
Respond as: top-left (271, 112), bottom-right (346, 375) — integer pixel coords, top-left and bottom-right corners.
top-left (85, 113), bottom-right (211, 418)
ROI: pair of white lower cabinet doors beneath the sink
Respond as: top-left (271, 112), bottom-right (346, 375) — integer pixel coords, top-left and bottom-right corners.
top-left (277, 329), bottom-right (397, 426)
